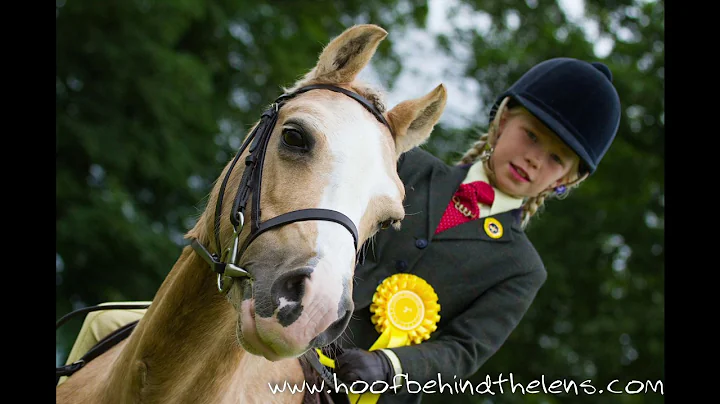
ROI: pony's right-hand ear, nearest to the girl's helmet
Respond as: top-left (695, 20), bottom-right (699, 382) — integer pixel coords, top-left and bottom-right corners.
top-left (387, 84), bottom-right (447, 156)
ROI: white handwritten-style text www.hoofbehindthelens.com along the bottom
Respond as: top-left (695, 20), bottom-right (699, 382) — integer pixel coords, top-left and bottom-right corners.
top-left (268, 373), bottom-right (665, 395)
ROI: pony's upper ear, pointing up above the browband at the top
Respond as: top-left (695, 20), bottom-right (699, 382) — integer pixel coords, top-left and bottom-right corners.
top-left (302, 24), bottom-right (387, 83)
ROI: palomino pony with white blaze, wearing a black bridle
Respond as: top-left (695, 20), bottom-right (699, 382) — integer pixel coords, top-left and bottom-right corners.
top-left (56, 25), bottom-right (447, 404)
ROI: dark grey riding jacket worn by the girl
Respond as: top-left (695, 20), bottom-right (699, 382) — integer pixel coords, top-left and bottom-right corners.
top-left (338, 148), bottom-right (547, 403)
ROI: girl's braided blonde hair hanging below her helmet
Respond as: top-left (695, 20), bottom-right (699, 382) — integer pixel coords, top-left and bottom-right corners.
top-left (457, 97), bottom-right (588, 229)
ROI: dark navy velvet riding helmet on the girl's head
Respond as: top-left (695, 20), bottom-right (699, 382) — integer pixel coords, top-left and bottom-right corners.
top-left (490, 58), bottom-right (621, 174)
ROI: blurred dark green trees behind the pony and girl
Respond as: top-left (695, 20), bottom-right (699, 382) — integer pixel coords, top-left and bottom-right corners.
top-left (56, 0), bottom-right (665, 403)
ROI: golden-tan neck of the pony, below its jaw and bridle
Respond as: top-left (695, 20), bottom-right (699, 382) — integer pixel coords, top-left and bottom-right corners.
top-left (106, 246), bottom-right (243, 403)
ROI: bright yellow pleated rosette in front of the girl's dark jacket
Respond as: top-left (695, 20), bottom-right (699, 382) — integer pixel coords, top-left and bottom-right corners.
top-left (348, 273), bottom-right (440, 404)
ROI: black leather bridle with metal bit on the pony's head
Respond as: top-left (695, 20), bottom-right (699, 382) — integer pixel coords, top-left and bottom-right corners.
top-left (192, 84), bottom-right (393, 293)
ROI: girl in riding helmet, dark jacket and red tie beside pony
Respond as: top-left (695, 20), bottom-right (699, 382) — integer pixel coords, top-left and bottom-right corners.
top-left (333, 58), bottom-right (621, 403)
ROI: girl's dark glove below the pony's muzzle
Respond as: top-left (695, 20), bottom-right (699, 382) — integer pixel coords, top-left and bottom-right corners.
top-left (335, 348), bottom-right (395, 386)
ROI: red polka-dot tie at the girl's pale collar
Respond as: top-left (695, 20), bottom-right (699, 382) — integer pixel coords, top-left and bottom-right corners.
top-left (435, 181), bottom-right (495, 234)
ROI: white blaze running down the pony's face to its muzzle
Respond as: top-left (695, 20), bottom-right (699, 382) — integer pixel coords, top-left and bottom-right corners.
top-left (268, 96), bottom-right (400, 354)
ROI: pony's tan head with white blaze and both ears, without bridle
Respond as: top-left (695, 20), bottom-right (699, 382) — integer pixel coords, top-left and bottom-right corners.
top-left (189, 25), bottom-right (447, 360)
